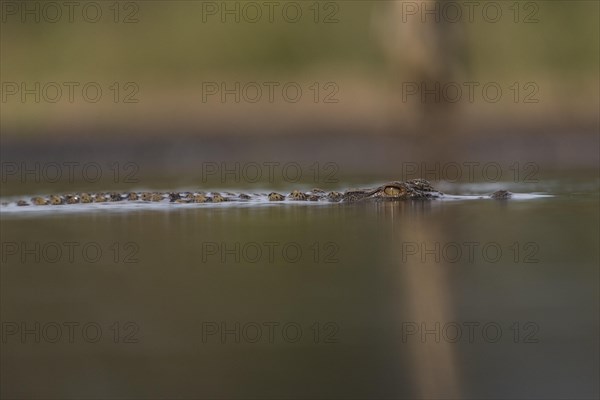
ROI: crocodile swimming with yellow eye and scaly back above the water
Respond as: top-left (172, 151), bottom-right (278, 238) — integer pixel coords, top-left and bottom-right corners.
top-left (3, 179), bottom-right (512, 206)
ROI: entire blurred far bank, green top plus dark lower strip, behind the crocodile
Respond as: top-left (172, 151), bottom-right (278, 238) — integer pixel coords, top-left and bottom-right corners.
top-left (0, 1), bottom-right (600, 194)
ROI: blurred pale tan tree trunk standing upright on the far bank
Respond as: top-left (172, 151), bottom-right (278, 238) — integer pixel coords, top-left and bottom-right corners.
top-left (374, 0), bottom-right (467, 141)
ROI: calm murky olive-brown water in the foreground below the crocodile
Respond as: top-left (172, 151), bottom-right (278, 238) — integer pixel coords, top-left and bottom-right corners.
top-left (0, 184), bottom-right (599, 398)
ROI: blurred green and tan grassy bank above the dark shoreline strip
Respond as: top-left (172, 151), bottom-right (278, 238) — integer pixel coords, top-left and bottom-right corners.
top-left (0, 1), bottom-right (600, 137)
